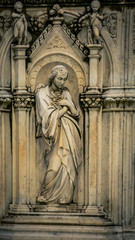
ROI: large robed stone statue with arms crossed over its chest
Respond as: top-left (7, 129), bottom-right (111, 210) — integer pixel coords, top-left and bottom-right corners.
top-left (36, 65), bottom-right (82, 204)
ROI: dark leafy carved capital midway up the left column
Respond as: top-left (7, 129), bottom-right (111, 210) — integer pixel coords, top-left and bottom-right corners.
top-left (13, 96), bottom-right (34, 110)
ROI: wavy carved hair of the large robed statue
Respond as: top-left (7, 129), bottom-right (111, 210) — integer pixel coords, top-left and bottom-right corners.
top-left (48, 65), bottom-right (68, 85)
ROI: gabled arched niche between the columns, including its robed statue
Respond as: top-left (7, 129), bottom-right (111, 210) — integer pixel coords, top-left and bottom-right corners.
top-left (27, 2), bottom-right (88, 210)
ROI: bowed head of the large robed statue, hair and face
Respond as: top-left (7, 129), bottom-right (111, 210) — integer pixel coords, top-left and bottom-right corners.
top-left (48, 65), bottom-right (68, 86)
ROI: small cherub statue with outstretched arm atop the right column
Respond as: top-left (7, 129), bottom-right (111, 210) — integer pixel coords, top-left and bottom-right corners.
top-left (79, 0), bottom-right (103, 44)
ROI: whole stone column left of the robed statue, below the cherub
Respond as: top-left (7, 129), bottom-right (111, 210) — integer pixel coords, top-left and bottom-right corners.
top-left (11, 45), bottom-right (34, 212)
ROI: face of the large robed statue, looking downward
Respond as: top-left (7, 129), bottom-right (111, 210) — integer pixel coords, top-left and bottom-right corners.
top-left (52, 72), bottom-right (67, 89)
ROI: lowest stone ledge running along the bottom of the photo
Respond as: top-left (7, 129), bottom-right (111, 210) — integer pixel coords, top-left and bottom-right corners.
top-left (0, 224), bottom-right (123, 240)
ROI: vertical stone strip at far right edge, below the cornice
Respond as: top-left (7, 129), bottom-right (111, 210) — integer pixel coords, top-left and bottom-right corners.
top-left (123, 112), bottom-right (135, 225)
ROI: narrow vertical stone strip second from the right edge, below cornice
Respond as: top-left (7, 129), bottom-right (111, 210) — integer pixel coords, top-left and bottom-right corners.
top-left (112, 112), bottom-right (123, 224)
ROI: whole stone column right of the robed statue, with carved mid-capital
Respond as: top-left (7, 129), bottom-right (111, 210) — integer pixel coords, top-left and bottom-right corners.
top-left (81, 45), bottom-right (102, 211)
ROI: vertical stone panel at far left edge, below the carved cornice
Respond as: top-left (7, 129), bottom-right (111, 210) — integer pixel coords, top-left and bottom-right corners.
top-left (0, 109), bottom-right (12, 216)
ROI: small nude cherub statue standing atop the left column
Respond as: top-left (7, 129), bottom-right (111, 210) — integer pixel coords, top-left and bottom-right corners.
top-left (12, 2), bottom-right (27, 45)
